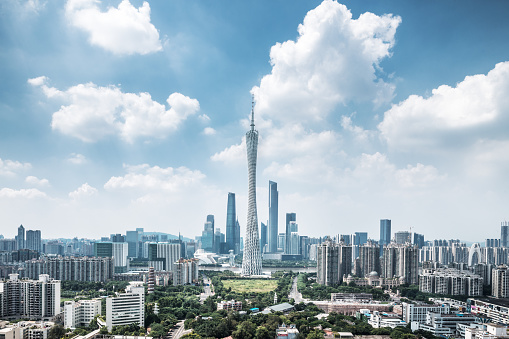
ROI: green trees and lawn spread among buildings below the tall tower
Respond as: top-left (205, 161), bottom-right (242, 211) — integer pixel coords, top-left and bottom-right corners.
top-left (55, 271), bottom-right (450, 339)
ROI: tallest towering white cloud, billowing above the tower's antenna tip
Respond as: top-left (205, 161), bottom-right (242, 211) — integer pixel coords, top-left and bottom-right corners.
top-left (253, 0), bottom-right (401, 120)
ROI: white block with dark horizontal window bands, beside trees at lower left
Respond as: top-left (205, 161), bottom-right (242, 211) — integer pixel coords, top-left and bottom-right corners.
top-left (106, 281), bottom-right (145, 331)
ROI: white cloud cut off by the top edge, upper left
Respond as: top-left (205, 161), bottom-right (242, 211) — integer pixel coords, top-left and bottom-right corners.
top-left (65, 0), bottom-right (162, 55)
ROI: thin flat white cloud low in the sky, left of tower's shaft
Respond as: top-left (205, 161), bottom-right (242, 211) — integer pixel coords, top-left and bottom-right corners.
top-left (104, 164), bottom-right (205, 192)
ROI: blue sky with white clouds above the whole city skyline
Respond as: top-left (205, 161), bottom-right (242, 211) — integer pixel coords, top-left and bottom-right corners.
top-left (0, 0), bottom-right (509, 242)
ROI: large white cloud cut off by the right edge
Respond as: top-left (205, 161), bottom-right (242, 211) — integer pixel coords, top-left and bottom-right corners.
top-left (378, 62), bottom-right (509, 151)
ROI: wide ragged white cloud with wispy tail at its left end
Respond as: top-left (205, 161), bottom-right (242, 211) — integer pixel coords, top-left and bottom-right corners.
top-left (28, 77), bottom-right (200, 143)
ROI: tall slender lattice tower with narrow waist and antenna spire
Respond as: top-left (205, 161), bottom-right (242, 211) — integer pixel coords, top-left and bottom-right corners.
top-left (242, 102), bottom-right (262, 275)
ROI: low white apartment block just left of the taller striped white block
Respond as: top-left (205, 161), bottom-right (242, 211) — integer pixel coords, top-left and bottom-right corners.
top-left (64, 298), bottom-right (101, 329)
